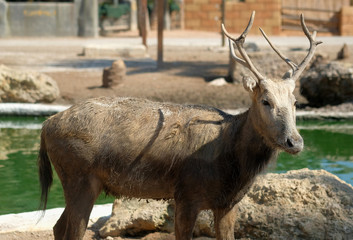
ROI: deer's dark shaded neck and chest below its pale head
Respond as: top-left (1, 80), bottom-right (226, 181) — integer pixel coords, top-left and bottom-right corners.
top-left (217, 109), bottom-right (277, 204)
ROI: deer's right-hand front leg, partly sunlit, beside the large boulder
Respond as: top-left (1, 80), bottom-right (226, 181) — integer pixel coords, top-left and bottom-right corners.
top-left (213, 206), bottom-right (237, 240)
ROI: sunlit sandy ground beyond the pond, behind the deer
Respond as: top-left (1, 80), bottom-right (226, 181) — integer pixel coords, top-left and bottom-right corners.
top-left (0, 31), bottom-right (353, 109)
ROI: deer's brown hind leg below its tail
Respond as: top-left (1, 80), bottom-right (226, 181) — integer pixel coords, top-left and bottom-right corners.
top-left (54, 175), bottom-right (102, 240)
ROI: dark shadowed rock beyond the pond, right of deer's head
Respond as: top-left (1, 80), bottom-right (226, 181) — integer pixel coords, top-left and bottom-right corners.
top-left (300, 62), bottom-right (353, 107)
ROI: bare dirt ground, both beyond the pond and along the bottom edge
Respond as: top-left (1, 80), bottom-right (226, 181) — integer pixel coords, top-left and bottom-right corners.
top-left (0, 32), bottom-right (353, 240)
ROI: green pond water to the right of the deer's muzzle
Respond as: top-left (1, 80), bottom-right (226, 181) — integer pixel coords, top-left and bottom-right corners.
top-left (275, 121), bottom-right (353, 185)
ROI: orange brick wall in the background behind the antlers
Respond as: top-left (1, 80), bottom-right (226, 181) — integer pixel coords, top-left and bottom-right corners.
top-left (184, 0), bottom-right (353, 35)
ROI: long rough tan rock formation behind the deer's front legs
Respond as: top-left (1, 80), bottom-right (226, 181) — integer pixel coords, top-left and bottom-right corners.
top-left (100, 169), bottom-right (353, 239)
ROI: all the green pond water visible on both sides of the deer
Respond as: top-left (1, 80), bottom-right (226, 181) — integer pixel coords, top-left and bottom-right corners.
top-left (0, 117), bottom-right (353, 215)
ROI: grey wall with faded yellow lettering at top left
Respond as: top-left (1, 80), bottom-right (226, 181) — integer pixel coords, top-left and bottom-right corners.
top-left (0, 0), bottom-right (98, 37)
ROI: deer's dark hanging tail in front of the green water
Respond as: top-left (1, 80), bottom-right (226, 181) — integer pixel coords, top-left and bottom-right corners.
top-left (37, 135), bottom-right (53, 211)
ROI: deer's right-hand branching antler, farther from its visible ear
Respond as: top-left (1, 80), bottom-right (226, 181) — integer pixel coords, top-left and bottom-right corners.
top-left (260, 14), bottom-right (322, 81)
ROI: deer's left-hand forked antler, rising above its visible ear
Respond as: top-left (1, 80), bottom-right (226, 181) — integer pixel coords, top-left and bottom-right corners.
top-left (222, 11), bottom-right (265, 81)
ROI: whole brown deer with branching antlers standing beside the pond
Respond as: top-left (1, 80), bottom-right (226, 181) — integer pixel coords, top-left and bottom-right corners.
top-left (38, 13), bottom-right (320, 240)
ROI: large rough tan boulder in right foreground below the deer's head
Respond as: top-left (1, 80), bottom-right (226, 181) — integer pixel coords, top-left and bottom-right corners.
top-left (235, 169), bottom-right (353, 239)
